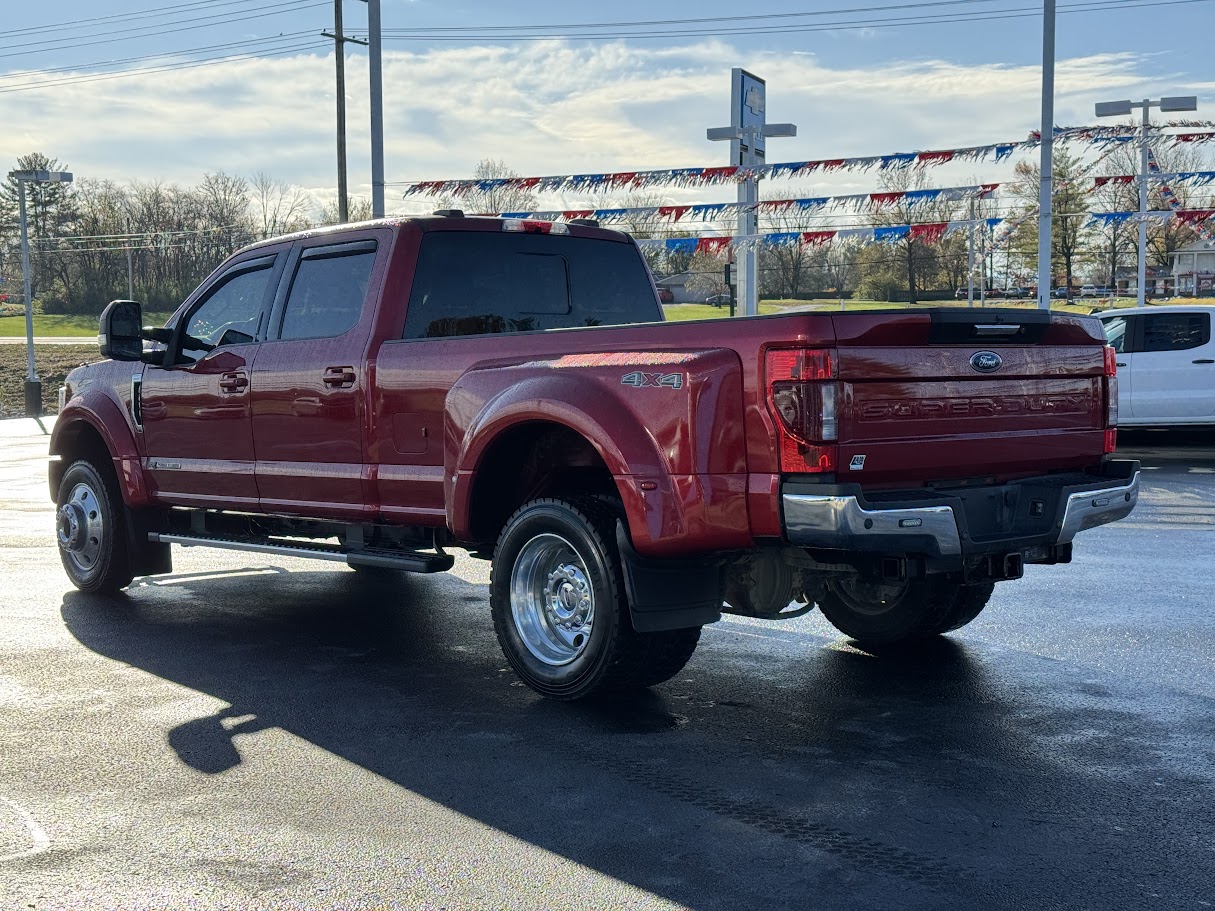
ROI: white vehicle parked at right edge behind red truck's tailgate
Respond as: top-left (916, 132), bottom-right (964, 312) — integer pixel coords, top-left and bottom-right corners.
top-left (1097, 306), bottom-right (1215, 428)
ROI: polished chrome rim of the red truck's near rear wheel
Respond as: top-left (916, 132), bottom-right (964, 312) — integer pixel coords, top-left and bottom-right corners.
top-left (510, 533), bottom-right (595, 667)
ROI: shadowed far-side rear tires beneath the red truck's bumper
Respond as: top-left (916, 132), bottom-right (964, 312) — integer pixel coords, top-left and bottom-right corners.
top-left (819, 576), bottom-right (993, 645)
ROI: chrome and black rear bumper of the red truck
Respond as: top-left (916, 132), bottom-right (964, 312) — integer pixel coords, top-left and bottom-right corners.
top-left (781, 460), bottom-right (1140, 563)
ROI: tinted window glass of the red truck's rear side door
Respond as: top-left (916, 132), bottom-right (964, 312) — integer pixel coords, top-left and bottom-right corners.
top-left (278, 245), bottom-right (375, 339)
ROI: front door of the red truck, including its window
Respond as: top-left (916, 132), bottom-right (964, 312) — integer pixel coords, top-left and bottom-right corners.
top-left (140, 254), bottom-right (276, 509)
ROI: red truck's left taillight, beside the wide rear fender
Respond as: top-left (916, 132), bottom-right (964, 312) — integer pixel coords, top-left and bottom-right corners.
top-left (764, 349), bottom-right (840, 474)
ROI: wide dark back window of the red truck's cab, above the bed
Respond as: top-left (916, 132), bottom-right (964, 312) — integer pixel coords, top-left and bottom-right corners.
top-left (403, 231), bottom-right (662, 339)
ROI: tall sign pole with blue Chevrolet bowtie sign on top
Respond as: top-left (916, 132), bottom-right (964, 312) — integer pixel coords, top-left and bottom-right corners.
top-left (706, 67), bottom-right (797, 316)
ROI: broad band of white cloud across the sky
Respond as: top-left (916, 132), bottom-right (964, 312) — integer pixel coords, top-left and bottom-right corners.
top-left (0, 41), bottom-right (1215, 210)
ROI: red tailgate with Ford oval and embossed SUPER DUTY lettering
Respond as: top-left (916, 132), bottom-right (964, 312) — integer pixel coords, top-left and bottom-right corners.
top-left (835, 310), bottom-right (1107, 483)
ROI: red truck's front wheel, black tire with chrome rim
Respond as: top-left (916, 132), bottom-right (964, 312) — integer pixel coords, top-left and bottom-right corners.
top-left (55, 459), bottom-right (135, 594)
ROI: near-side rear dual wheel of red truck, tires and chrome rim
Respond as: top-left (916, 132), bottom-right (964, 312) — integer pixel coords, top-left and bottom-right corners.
top-left (490, 498), bottom-right (700, 700)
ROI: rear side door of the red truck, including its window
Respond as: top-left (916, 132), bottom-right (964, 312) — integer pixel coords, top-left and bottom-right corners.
top-left (250, 231), bottom-right (389, 521)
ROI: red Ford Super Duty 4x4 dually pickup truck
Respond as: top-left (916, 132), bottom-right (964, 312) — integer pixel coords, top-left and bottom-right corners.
top-left (50, 211), bottom-right (1138, 698)
